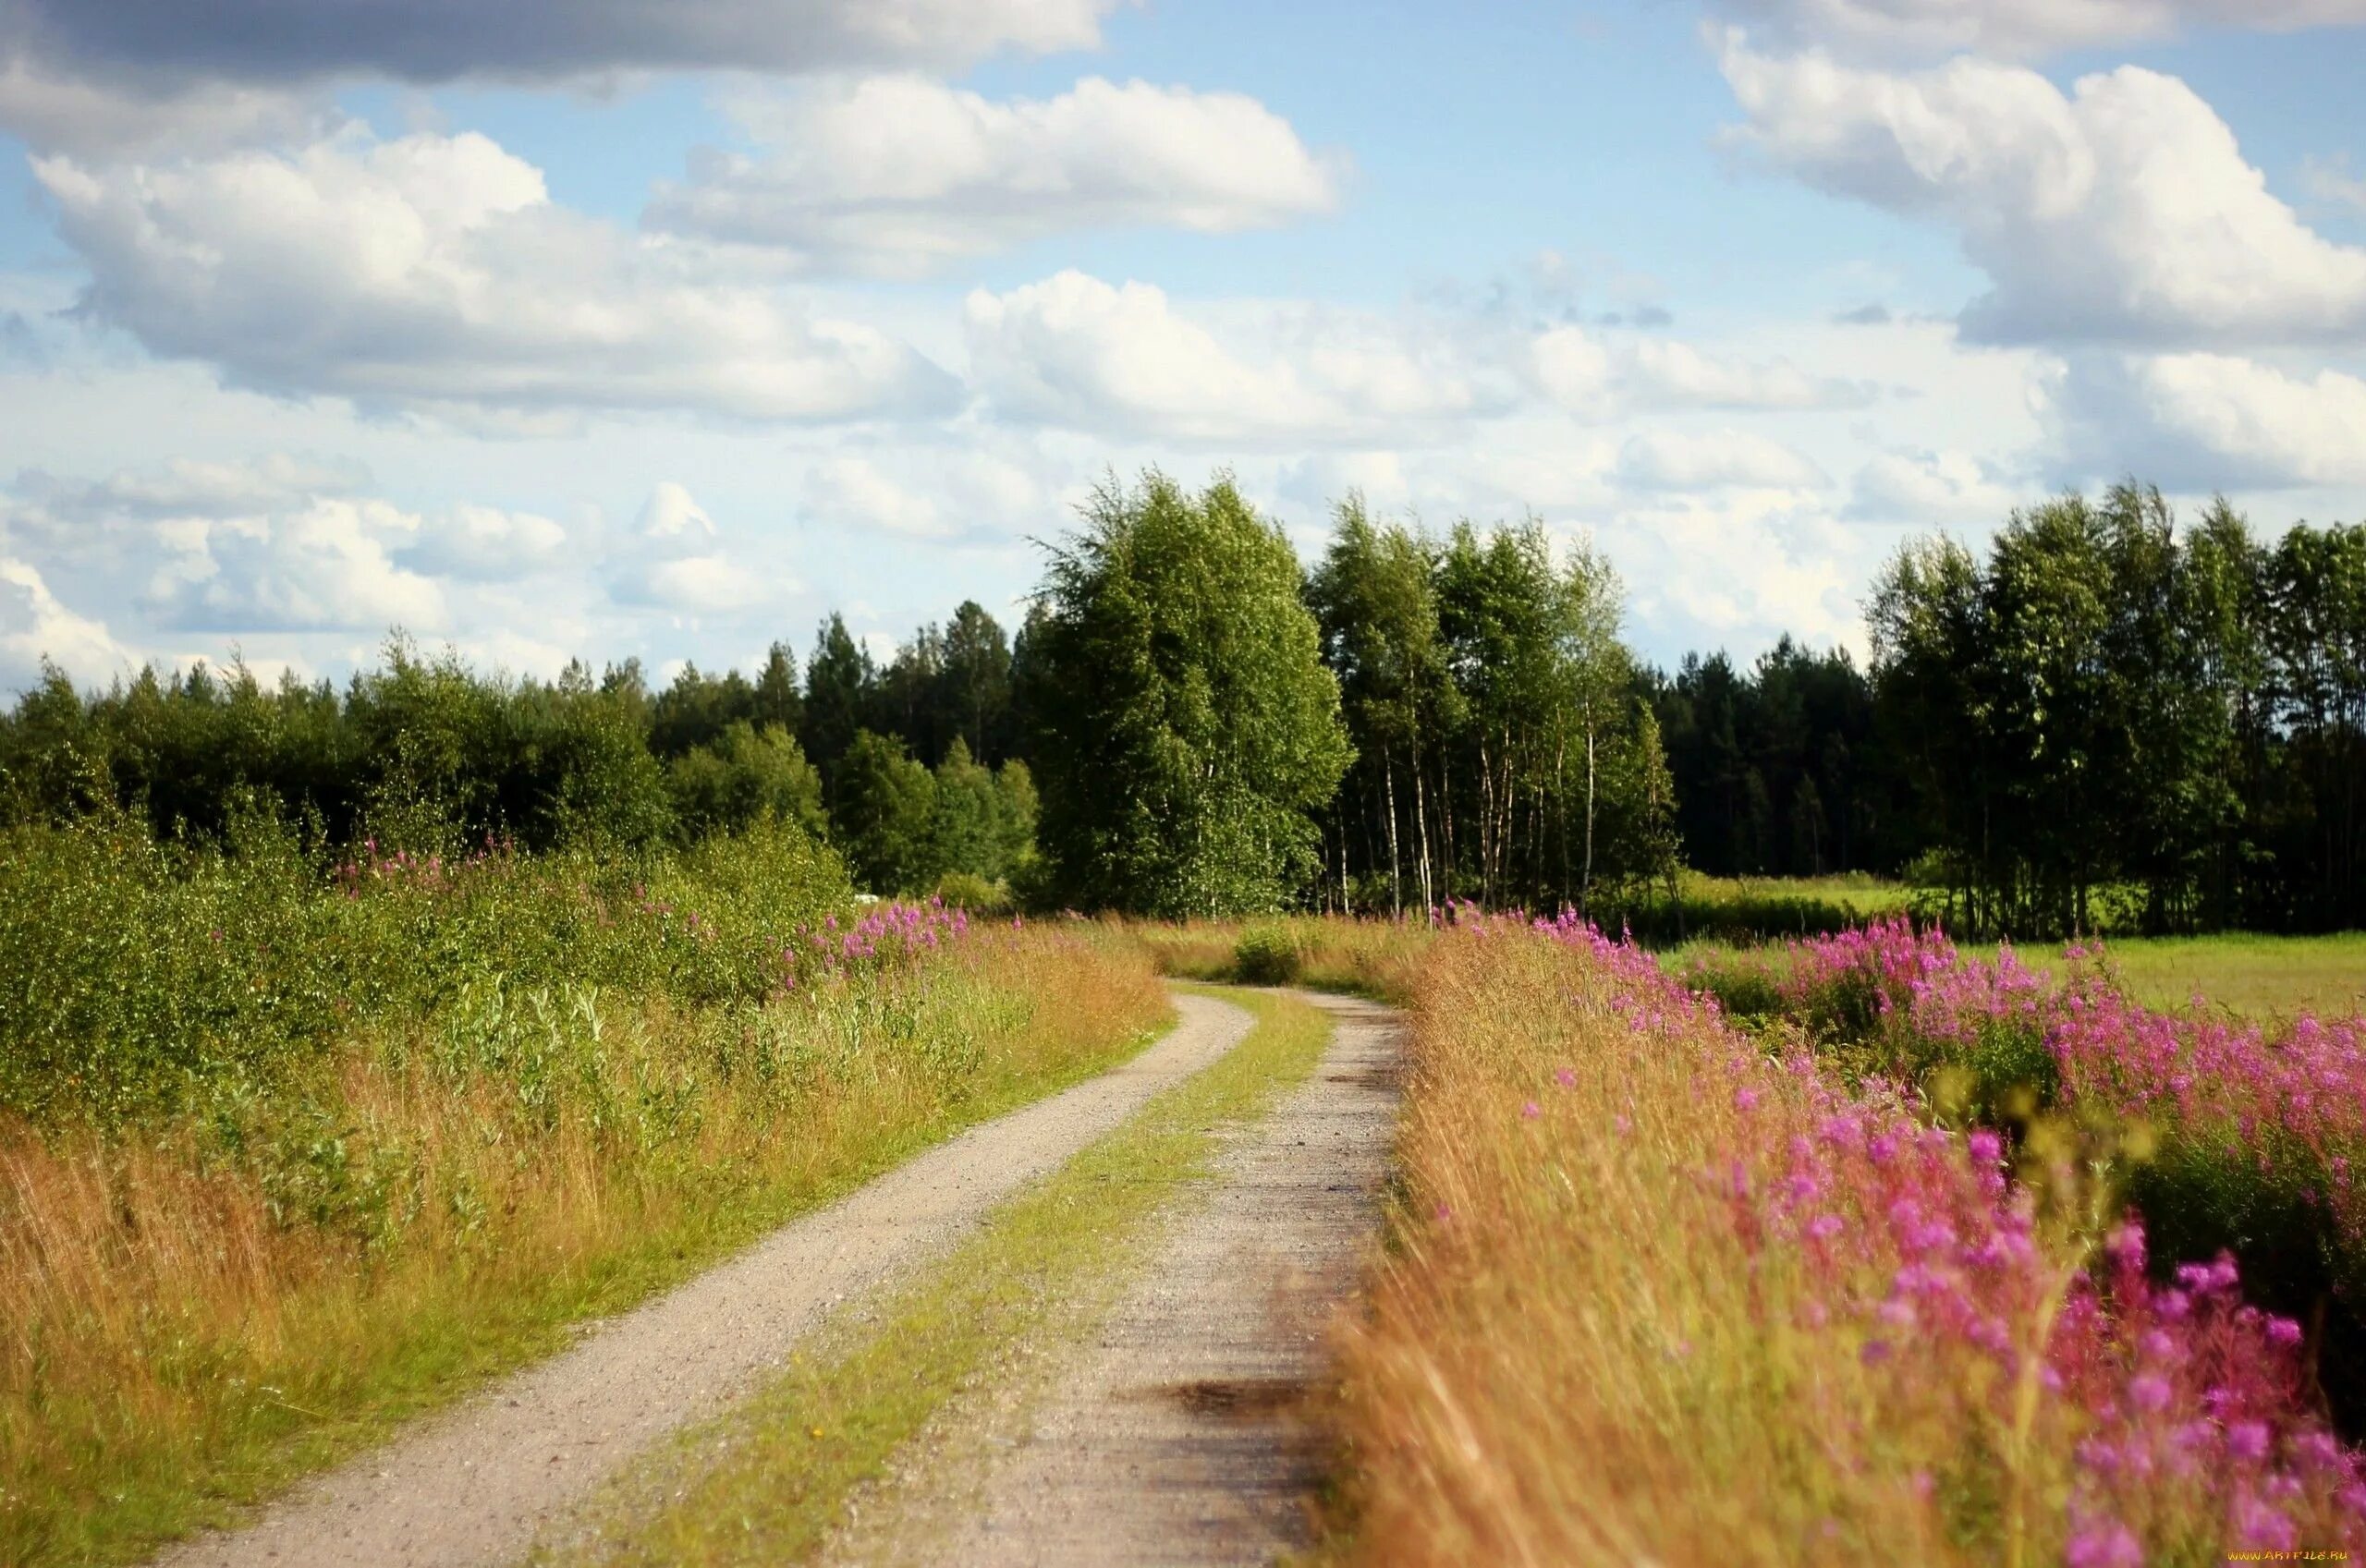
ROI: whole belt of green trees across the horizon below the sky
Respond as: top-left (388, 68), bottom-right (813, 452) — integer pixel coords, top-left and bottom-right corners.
top-left (0, 473), bottom-right (2366, 937)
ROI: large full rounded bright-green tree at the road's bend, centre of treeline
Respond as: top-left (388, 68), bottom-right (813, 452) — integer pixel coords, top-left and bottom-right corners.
top-left (1027, 473), bottom-right (1353, 916)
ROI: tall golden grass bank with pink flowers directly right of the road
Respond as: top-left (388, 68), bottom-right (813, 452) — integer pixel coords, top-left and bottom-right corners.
top-left (1336, 922), bottom-right (2366, 1568)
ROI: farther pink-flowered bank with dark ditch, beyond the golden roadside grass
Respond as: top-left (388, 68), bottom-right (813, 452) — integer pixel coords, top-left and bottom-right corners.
top-left (1687, 922), bottom-right (2366, 1436)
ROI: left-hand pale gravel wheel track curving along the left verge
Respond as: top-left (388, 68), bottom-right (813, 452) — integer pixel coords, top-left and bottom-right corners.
top-left (156, 996), bottom-right (1250, 1568)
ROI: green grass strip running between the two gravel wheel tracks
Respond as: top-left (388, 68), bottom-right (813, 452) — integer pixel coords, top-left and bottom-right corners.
top-left (535, 991), bottom-right (1332, 1565)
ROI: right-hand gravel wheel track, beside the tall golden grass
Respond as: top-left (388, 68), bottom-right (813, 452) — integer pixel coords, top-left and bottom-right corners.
top-left (835, 996), bottom-right (1403, 1568)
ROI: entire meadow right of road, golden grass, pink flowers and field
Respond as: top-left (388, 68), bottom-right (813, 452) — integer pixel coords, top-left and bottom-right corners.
top-left (1102, 910), bottom-right (2366, 1565)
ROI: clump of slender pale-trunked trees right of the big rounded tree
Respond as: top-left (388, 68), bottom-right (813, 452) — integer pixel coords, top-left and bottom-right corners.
top-left (1306, 497), bottom-right (1677, 913)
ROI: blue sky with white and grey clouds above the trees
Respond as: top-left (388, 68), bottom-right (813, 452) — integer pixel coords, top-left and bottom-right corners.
top-left (0, 0), bottom-right (2366, 690)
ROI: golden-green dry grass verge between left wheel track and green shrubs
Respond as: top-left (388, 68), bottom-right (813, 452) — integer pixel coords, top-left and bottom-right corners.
top-left (0, 931), bottom-right (1166, 1563)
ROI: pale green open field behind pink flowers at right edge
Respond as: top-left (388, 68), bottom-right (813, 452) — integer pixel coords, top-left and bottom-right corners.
top-left (2092, 931), bottom-right (2366, 1019)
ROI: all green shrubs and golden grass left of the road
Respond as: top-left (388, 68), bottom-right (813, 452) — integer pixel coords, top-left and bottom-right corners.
top-left (0, 820), bottom-right (1169, 1563)
